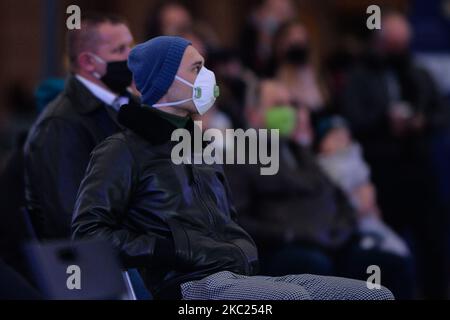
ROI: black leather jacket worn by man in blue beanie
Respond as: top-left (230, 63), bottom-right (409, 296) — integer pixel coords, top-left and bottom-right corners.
top-left (72, 106), bottom-right (257, 298)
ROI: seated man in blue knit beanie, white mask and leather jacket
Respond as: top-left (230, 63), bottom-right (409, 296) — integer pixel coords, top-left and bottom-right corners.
top-left (72, 37), bottom-right (392, 300)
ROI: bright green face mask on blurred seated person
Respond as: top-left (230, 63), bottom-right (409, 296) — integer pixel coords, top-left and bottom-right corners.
top-left (266, 106), bottom-right (296, 137)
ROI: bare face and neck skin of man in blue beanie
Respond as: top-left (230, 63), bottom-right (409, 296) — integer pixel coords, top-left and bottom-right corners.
top-left (161, 46), bottom-right (205, 115)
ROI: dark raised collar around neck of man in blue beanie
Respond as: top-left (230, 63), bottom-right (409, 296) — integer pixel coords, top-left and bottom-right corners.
top-left (118, 104), bottom-right (194, 145)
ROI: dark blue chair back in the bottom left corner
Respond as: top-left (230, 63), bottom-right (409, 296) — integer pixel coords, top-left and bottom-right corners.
top-left (26, 240), bottom-right (131, 300)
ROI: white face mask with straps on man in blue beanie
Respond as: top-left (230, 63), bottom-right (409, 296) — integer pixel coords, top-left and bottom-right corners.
top-left (153, 67), bottom-right (219, 115)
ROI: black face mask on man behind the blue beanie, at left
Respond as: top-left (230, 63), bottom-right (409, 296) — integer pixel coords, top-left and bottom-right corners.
top-left (100, 60), bottom-right (133, 94)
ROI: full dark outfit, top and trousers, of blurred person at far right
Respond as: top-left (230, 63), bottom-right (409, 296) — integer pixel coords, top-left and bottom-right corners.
top-left (339, 56), bottom-right (450, 229)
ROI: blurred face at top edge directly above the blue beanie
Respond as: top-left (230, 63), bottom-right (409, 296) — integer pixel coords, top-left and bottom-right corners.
top-left (161, 5), bottom-right (192, 35)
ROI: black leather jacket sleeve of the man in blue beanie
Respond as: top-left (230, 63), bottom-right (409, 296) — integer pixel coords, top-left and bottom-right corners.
top-left (72, 138), bottom-right (175, 267)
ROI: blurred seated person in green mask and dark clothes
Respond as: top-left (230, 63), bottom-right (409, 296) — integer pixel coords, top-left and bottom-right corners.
top-left (225, 80), bottom-right (413, 299)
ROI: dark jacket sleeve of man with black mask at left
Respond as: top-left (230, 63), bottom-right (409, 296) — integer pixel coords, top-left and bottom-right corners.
top-left (25, 118), bottom-right (93, 237)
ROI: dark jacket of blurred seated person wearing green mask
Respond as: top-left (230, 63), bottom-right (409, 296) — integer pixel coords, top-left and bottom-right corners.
top-left (225, 140), bottom-right (356, 250)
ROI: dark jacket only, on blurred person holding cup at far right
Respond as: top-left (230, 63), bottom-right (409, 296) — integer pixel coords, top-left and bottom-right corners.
top-left (336, 54), bottom-right (449, 144)
